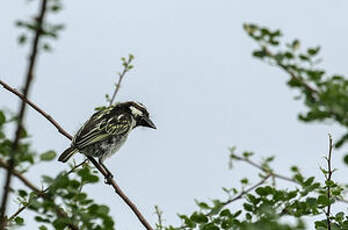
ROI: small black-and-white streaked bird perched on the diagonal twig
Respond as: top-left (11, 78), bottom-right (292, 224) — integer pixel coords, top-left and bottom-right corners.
top-left (58, 101), bottom-right (156, 177)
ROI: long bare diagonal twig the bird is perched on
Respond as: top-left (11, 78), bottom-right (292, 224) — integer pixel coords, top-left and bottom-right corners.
top-left (0, 81), bottom-right (153, 230)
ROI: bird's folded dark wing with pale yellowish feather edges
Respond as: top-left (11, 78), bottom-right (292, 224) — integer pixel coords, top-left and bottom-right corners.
top-left (73, 112), bottom-right (132, 149)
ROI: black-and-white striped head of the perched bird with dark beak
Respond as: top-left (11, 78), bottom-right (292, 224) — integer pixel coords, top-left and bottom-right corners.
top-left (125, 101), bottom-right (156, 129)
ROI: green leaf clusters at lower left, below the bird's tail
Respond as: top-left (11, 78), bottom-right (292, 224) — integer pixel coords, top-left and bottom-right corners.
top-left (0, 111), bottom-right (114, 230)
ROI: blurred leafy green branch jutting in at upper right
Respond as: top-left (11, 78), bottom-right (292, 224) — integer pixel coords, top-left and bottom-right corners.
top-left (244, 24), bottom-right (348, 148)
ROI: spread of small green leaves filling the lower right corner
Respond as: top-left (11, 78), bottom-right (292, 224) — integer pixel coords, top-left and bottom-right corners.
top-left (158, 148), bottom-right (348, 230)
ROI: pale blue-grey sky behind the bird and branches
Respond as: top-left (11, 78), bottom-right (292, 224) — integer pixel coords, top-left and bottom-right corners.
top-left (0, 0), bottom-right (348, 230)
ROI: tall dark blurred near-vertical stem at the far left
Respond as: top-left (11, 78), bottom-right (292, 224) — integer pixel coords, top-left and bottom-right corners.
top-left (0, 0), bottom-right (47, 226)
